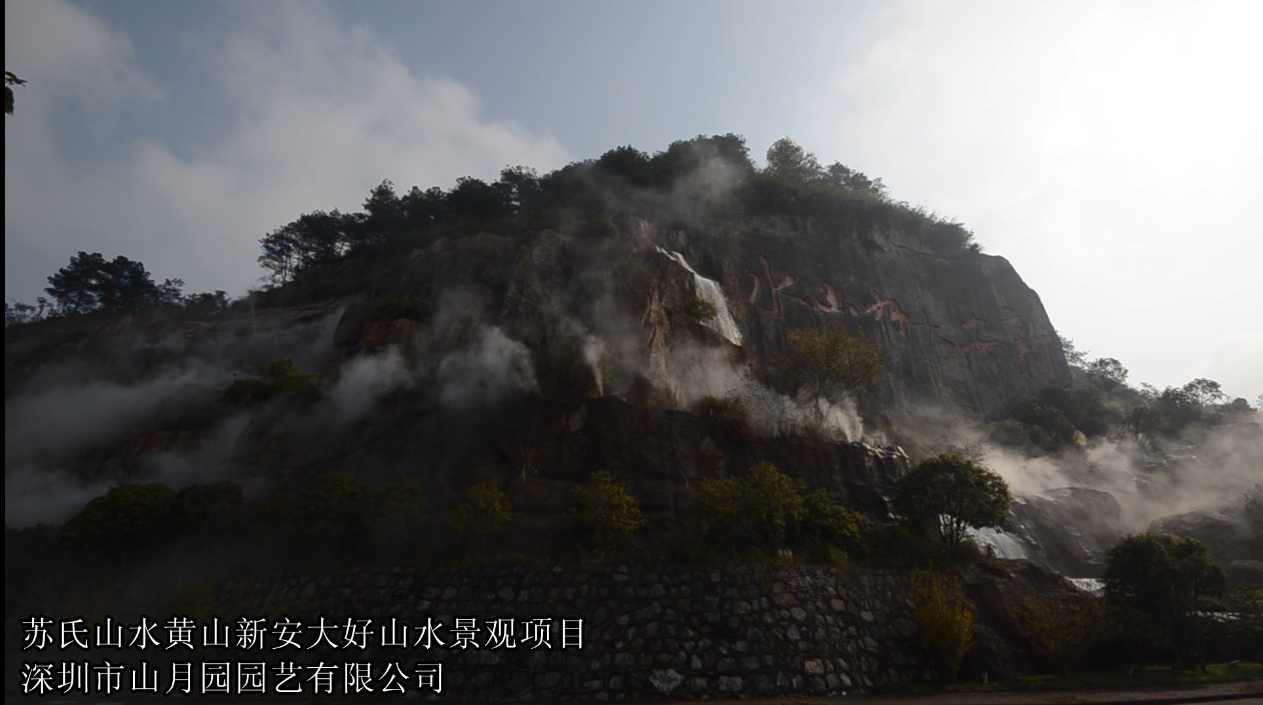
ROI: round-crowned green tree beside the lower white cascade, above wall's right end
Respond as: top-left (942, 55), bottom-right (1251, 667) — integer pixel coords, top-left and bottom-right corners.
top-left (894, 454), bottom-right (1012, 548)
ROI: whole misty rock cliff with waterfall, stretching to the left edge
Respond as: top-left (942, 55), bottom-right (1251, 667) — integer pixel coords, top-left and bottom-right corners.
top-left (5, 217), bottom-right (1068, 535)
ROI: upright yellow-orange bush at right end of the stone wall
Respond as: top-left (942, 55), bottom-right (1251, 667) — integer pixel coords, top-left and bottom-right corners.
top-left (914, 574), bottom-right (974, 682)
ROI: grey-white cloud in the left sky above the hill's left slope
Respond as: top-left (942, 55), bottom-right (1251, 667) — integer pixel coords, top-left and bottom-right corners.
top-left (5, 0), bottom-right (567, 297)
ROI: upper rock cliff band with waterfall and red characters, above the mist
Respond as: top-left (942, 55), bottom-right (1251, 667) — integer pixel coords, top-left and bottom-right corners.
top-left (281, 212), bottom-right (1070, 413)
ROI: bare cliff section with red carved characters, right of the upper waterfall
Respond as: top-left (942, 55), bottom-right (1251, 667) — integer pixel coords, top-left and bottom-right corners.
top-left (641, 219), bottom-right (1070, 412)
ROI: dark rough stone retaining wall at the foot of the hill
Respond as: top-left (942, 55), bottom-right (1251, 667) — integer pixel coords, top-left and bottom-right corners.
top-left (220, 566), bottom-right (926, 702)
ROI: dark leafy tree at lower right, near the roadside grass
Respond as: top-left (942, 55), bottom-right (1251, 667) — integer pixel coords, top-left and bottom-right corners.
top-left (1104, 533), bottom-right (1224, 657)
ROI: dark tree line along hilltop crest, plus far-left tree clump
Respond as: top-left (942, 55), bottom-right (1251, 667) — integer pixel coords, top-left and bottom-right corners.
top-left (5, 134), bottom-right (978, 325)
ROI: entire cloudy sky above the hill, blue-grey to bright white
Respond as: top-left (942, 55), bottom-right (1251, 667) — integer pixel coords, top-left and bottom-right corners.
top-left (5, 0), bottom-right (1263, 401)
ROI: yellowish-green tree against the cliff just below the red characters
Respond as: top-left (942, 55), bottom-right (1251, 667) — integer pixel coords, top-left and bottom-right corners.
top-left (777, 328), bottom-right (882, 398)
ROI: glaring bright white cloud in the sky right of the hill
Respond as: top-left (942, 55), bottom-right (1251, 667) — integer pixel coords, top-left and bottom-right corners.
top-left (812, 0), bottom-right (1263, 397)
